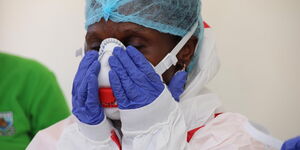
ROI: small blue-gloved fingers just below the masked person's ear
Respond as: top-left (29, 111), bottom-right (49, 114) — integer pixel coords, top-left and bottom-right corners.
top-left (168, 71), bottom-right (187, 102)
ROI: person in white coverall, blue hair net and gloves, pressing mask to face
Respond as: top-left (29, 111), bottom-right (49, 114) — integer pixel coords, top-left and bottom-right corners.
top-left (27, 0), bottom-right (282, 150)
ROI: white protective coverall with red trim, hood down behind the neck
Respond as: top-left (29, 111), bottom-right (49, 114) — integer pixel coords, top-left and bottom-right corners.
top-left (27, 24), bottom-right (282, 150)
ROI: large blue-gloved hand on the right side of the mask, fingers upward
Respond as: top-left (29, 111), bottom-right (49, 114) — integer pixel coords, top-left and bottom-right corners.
top-left (109, 46), bottom-right (164, 109)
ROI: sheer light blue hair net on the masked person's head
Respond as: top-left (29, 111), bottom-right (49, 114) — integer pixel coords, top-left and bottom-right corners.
top-left (85, 0), bottom-right (203, 69)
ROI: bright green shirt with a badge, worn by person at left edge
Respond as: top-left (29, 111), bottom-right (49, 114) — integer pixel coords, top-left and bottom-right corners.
top-left (0, 53), bottom-right (70, 150)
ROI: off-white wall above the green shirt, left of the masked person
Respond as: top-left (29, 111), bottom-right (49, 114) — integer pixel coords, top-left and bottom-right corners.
top-left (0, 0), bottom-right (85, 104)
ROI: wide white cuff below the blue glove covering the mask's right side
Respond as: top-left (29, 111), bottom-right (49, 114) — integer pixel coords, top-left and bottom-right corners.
top-left (120, 86), bottom-right (178, 131)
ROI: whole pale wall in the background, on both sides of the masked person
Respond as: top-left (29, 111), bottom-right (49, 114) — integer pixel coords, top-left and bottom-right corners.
top-left (0, 0), bottom-right (300, 139)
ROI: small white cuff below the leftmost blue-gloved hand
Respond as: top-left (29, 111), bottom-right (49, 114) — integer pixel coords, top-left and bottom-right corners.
top-left (77, 117), bottom-right (112, 141)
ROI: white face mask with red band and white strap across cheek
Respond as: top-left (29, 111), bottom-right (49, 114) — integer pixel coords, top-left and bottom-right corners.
top-left (98, 23), bottom-right (198, 120)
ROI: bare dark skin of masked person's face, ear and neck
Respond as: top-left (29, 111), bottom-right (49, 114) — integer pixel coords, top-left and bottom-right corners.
top-left (85, 19), bottom-right (198, 84)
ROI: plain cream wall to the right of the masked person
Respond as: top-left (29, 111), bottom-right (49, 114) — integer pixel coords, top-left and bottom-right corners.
top-left (203, 0), bottom-right (300, 139)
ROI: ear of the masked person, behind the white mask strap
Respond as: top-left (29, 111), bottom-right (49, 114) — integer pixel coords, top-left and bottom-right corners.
top-left (177, 36), bottom-right (198, 69)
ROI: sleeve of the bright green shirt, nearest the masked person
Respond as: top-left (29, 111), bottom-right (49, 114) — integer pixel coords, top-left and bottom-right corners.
top-left (21, 63), bottom-right (70, 137)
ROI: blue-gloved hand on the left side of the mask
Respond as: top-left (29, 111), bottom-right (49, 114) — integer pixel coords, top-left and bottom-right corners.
top-left (72, 51), bottom-right (104, 125)
